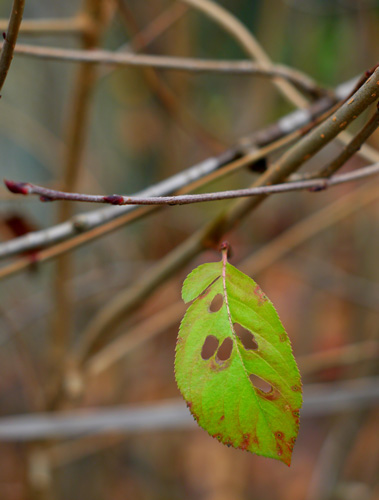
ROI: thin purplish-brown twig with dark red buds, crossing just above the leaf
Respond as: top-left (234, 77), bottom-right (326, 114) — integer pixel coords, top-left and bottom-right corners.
top-left (4, 163), bottom-right (379, 206)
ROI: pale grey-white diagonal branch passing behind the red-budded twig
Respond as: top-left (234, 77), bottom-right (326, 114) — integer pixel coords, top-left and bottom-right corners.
top-left (0, 79), bottom-right (356, 264)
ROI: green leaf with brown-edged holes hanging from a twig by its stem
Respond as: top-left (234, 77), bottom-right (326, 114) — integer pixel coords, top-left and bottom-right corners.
top-left (175, 248), bottom-right (302, 465)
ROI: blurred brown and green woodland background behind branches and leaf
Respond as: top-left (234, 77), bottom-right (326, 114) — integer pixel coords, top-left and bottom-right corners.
top-left (0, 0), bottom-right (379, 500)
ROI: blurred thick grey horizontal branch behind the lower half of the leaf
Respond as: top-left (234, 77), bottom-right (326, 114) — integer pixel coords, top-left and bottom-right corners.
top-left (0, 377), bottom-right (379, 441)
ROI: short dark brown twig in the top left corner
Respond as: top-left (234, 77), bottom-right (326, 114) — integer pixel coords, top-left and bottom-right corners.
top-left (0, 0), bottom-right (25, 92)
